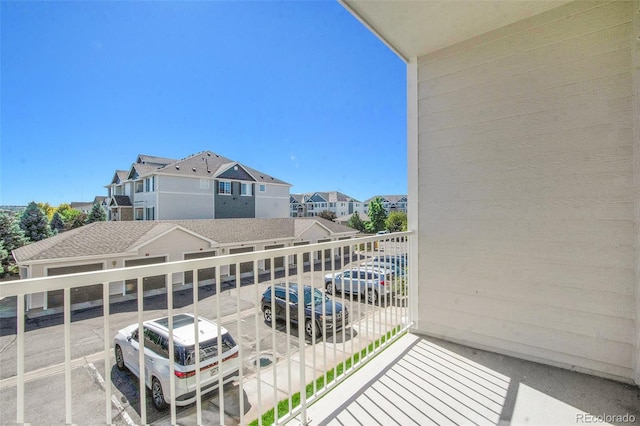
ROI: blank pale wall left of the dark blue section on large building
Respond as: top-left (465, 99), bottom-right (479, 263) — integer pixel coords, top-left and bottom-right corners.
top-left (156, 176), bottom-right (214, 220)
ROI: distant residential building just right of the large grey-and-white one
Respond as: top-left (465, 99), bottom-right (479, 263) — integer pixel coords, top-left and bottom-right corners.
top-left (289, 191), bottom-right (365, 218)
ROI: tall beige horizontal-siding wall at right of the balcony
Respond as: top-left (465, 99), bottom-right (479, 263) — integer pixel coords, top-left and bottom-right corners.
top-left (410, 2), bottom-right (638, 380)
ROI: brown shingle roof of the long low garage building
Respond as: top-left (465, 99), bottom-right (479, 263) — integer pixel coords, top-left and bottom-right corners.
top-left (13, 218), bottom-right (354, 262)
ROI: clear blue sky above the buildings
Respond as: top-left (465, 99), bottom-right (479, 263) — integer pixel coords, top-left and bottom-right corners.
top-left (0, 0), bottom-right (407, 206)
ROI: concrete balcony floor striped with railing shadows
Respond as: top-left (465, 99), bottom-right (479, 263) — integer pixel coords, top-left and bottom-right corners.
top-left (288, 334), bottom-right (640, 426)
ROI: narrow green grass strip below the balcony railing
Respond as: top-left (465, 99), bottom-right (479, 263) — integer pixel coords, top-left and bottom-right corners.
top-left (249, 326), bottom-right (400, 426)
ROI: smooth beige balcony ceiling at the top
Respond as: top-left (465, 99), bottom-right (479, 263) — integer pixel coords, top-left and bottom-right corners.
top-left (339, 0), bottom-right (569, 60)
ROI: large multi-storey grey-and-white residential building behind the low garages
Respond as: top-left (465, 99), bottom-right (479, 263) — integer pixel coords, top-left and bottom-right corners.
top-left (107, 151), bottom-right (291, 221)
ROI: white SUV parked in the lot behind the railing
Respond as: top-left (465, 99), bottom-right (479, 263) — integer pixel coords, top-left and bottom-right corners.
top-left (114, 314), bottom-right (240, 410)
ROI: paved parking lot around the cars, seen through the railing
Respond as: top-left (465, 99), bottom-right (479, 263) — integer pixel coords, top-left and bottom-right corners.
top-left (0, 251), bottom-right (408, 424)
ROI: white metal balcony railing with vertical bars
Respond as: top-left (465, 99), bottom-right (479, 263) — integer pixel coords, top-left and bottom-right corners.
top-left (0, 232), bottom-right (415, 425)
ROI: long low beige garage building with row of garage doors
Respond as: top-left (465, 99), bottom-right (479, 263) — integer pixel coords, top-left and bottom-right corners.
top-left (13, 218), bottom-right (356, 310)
